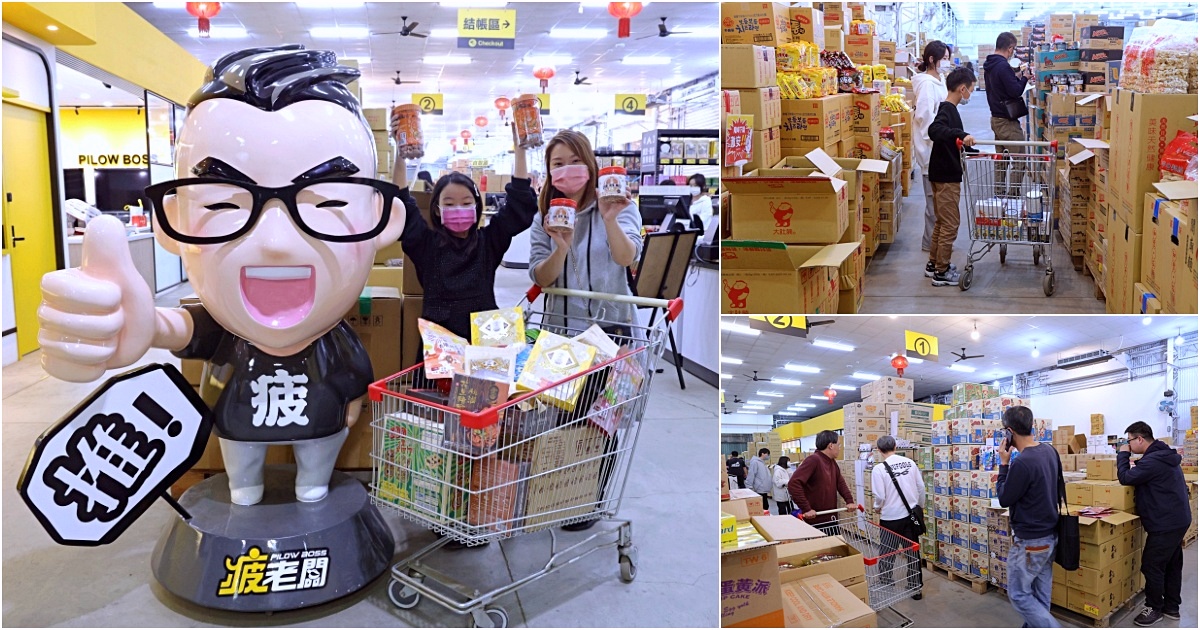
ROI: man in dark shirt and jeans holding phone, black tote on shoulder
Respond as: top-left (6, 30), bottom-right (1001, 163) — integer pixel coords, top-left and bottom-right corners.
top-left (996, 406), bottom-right (1062, 628)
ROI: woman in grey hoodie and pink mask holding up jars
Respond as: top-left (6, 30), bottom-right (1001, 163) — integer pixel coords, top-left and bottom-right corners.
top-left (529, 130), bottom-right (642, 335)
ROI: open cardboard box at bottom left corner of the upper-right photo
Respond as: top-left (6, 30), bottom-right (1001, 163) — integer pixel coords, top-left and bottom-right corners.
top-left (721, 241), bottom-right (858, 313)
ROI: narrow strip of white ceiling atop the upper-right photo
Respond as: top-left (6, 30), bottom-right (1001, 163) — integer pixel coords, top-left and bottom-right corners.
top-left (950, 1), bottom-right (1196, 24)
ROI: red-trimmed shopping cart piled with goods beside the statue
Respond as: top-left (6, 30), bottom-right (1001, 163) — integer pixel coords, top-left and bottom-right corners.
top-left (370, 287), bottom-right (683, 628)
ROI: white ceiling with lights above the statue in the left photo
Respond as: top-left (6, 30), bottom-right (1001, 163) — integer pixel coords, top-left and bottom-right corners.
top-left (128, 1), bottom-right (719, 157)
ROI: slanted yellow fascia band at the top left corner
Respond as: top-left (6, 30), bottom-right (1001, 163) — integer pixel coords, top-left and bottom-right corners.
top-left (4, 2), bottom-right (208, 103)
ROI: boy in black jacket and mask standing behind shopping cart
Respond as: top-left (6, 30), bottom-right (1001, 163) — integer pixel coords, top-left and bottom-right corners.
top-left (929, 67), bottom-right (976, 287)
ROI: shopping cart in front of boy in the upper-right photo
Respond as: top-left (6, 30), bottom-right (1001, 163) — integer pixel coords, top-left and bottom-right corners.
top-left (958, 139), bottom-right (1058, 295)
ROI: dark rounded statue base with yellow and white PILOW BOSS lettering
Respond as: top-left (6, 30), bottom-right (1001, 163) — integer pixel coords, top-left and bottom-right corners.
top-left (151, 466), bottom-right (395, 612)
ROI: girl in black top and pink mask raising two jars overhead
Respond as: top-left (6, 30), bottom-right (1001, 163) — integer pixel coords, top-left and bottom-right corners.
top-left (392, 123), bottom-right (538, 338)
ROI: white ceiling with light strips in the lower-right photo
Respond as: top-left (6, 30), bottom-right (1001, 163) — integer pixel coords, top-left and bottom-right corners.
top-left (721, 316), bottom-right (1196, 420)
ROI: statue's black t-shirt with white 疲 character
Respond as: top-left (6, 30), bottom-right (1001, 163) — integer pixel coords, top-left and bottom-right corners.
top-left (173, 305), bottom-right (373, 442)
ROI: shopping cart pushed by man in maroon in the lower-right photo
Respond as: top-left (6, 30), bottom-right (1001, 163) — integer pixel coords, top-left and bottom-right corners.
top-left (797, 508), bottom-right (920, 628)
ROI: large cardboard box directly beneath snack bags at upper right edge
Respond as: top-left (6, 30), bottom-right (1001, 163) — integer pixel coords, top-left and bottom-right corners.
top-left (1109, 89), bottom-right (1196, 213)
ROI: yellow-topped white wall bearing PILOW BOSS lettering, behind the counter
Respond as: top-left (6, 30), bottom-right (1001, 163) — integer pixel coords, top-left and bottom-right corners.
top-left (59, 107), bottom-right (148, 168)
